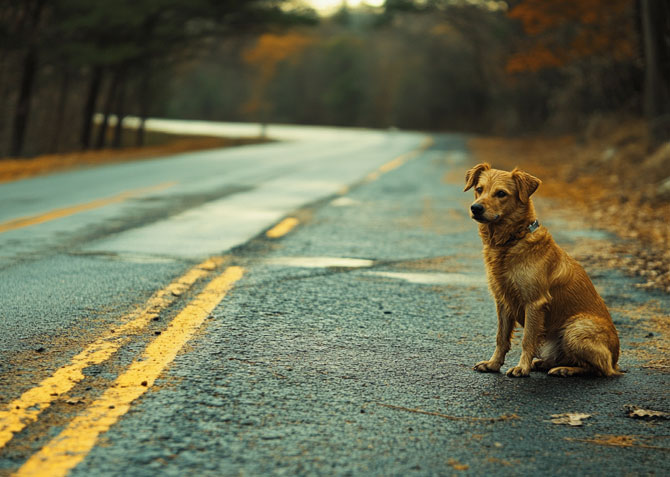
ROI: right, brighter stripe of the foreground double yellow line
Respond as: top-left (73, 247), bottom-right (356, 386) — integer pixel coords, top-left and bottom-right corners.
top-left (14, 266), bottom-right (244, 477)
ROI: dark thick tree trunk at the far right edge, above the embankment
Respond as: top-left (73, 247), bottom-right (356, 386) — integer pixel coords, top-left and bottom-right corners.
top-left (640, 0), bottom-right (670, 148)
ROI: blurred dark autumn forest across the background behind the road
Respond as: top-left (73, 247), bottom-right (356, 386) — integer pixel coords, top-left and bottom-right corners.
top-left (0, 0), bottom-right (670, 157)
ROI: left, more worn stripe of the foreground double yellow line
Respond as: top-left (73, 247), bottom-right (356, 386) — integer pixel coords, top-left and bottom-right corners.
top-left (0, 257), bottom-right (224, 449)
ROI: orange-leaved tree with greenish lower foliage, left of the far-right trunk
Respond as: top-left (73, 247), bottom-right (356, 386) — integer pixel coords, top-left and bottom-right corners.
top-left (506, 0), bottom-right (642, 130)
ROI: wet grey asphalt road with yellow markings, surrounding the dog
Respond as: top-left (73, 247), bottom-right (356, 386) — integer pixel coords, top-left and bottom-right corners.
top-left (0, 124), bottom-right (670, 476)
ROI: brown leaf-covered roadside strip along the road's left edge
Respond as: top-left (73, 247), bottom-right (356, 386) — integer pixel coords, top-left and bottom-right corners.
top-left (0, 127), bottom-right (267, 183)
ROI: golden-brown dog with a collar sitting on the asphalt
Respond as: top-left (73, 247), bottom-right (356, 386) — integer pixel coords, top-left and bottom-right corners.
top-left (464, 163), bottom-right (621, 377)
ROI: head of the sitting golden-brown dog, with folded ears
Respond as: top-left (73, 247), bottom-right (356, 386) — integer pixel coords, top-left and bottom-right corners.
top-left (464, 163), bottom-right (541, 224)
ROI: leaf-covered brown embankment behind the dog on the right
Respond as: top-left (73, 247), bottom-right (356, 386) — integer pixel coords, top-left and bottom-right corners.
top-left (469, 120), bottom-right (670, 293)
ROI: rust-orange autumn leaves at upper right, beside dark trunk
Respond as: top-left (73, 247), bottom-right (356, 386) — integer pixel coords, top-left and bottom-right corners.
top-left (506, 0), bottom-right (635, 73)
